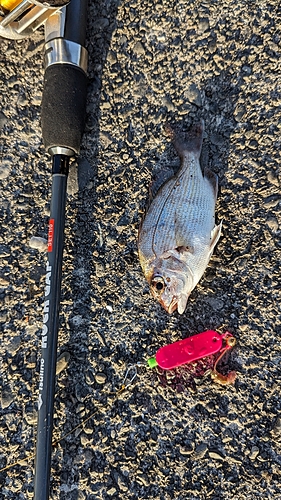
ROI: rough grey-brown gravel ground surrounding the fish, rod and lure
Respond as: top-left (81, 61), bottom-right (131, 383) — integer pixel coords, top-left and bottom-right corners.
top-left (0, 0), bottom-right (281, 500)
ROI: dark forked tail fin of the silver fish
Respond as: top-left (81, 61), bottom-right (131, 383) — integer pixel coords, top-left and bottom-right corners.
top-left (165, 119), bottom-right (204, 157)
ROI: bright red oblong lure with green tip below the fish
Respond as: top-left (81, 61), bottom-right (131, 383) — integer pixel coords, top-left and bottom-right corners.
top-left (148, 330), bottom-right (236, 385)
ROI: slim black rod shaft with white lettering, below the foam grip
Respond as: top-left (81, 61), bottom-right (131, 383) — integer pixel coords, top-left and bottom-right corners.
top-left (34, 155), bottom-right (69, 500)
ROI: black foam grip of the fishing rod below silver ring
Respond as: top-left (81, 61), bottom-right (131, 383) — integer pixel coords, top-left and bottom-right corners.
top-left (41, 64), bottom-right (87, 153)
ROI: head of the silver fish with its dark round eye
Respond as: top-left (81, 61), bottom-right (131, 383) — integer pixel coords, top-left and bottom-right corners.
top-left (150, 258), bottom-right (193, 314)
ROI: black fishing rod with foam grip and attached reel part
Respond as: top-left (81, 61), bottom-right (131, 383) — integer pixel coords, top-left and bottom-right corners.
top-left (0, 0), bottom-right (88, 500)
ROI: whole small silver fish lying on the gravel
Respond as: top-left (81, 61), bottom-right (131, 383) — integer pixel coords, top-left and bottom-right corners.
top-left (138, 120), bottom-right (222, 314)
